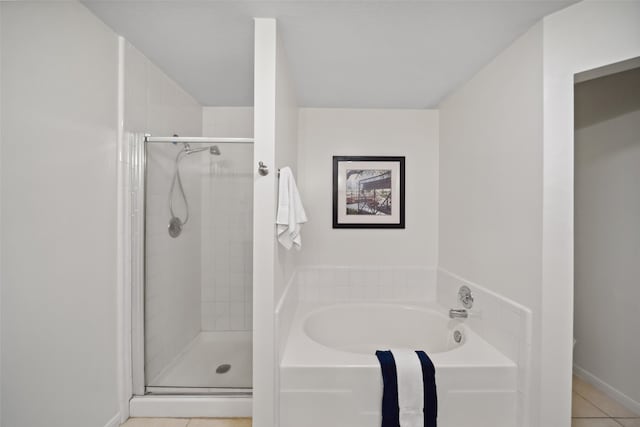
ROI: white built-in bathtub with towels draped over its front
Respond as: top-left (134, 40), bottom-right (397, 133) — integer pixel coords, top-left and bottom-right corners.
top-left (280, 303), bottom-right (517, 427)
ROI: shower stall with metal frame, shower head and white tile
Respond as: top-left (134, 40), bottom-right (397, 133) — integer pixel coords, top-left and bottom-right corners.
top-left (131, 135), bottom-right (253, 397)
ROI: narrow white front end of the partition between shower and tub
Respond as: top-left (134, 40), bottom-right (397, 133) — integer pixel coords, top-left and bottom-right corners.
top-left (253, 18), bottom-right (278, 427)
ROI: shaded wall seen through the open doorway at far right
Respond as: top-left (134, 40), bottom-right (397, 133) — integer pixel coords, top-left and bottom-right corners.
top-left (573, 68), bottom-right (640, 408)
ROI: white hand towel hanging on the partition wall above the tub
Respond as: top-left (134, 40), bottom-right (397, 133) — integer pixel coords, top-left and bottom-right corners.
top-left (276, 166), bottom-right (307, 249)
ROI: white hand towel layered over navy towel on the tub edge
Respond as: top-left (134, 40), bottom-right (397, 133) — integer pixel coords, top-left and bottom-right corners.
top-left (391, 349), bottom-right (424, 427)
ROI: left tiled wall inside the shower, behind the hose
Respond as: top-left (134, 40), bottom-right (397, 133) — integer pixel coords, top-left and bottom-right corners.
top-left (145, 144), bottom-right (201, 385)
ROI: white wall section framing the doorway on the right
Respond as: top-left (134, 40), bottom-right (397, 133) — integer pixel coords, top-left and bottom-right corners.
top-left (540, 1), bottom-right (640, 426)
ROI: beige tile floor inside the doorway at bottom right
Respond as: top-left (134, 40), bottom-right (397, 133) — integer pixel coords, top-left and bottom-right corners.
top-left (571, 376), bottom-right (640, 427)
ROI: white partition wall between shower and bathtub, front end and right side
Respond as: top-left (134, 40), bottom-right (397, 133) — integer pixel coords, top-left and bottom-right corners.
top-left (253, 18), bottom-right (297, 427)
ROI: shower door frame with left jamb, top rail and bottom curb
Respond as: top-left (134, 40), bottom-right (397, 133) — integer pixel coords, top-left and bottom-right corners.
top-left (119, 134), bottom-right (253, 420)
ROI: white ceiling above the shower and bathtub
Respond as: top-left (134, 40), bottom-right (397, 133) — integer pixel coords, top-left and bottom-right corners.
top-left (85, 0), bottom-right (575, 108)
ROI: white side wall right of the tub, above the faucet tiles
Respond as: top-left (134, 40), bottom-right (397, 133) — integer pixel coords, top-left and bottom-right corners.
top-left (439, 24), bottom-right (553, 425)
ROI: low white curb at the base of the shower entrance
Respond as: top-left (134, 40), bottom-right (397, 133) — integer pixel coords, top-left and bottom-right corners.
top-left (130, 396), bottom-right (252, 418)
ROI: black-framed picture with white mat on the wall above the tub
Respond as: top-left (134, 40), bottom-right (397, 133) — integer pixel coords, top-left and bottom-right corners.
top-left (333, 156), bottom-right (404, 228)
